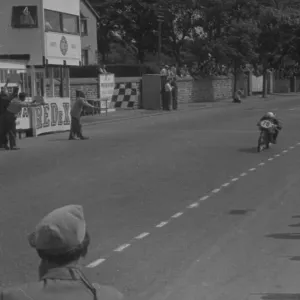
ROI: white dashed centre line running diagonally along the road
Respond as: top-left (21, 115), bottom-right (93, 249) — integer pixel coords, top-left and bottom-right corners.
top-left (87, 142), bottom-right (300, 268)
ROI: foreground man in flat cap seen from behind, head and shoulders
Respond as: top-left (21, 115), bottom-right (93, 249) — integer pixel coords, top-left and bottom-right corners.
top-left (0, 205), bottom-right (123, 300)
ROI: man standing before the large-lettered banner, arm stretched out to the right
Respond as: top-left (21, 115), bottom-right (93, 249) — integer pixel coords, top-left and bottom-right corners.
top-left (69, 91), bottom-right (97, 140)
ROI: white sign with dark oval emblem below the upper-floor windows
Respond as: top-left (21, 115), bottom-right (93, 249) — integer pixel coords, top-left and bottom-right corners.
top-left (45, 32), bottom-right (81, 65)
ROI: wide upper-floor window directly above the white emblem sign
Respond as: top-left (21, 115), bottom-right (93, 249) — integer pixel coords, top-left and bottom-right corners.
top-left (45, 9), bottom-right (79, 35)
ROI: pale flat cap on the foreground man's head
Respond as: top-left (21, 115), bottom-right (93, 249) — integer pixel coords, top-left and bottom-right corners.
top-left (28, 205), bottom-right (86, 255)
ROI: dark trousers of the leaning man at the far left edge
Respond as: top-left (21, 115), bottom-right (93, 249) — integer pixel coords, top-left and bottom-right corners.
top-left (0, 111), bottom-right (17, 149)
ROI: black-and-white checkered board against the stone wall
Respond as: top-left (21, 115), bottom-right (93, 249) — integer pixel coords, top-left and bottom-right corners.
top-left (112, 82), bottom-right (138, 108)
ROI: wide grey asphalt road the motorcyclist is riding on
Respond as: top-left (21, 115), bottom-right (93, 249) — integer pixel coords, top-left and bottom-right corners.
top-left (0, 97), bottom-right (300, 300)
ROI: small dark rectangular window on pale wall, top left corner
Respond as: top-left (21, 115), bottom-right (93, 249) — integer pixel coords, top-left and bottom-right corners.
top-left (11, 6), bottom-right (38, 28)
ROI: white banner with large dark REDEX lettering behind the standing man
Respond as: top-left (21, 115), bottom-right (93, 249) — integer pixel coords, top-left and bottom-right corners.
top-left (33, 98), bottom-right (71, 136)
